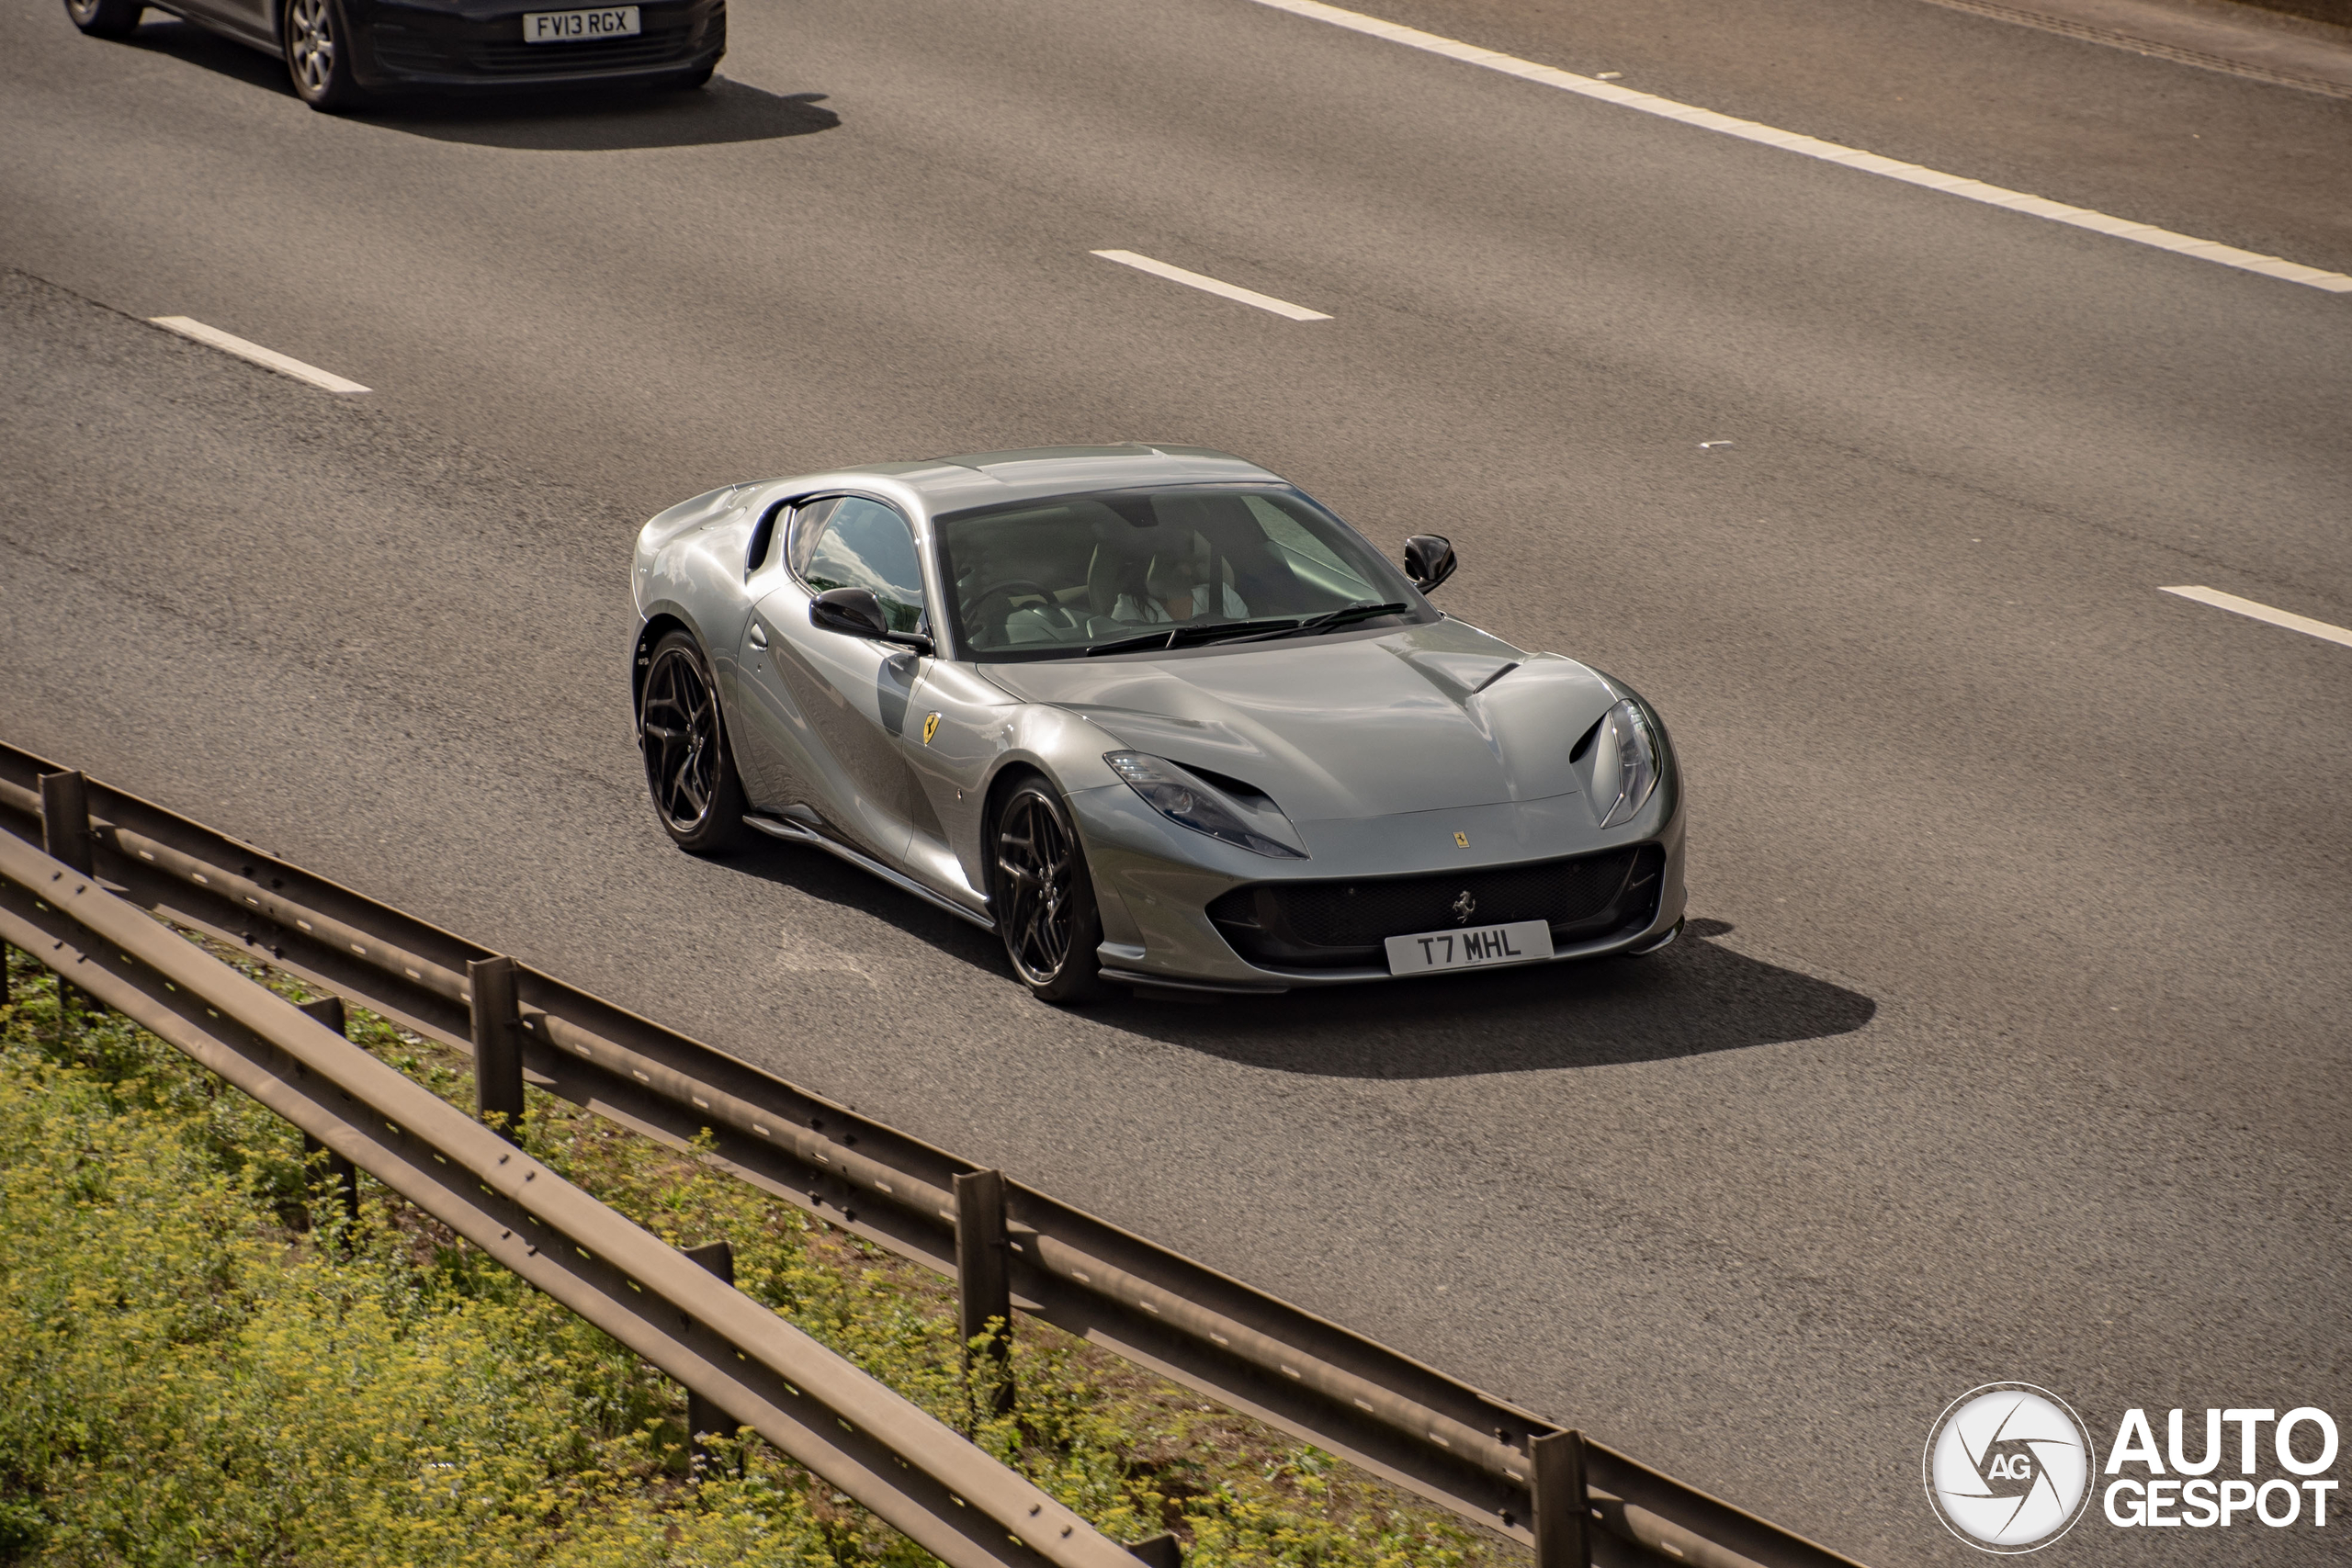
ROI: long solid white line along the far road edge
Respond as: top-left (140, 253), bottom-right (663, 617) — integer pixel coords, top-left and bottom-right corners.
top-left (1253, 0), bottom-right (2352, 294)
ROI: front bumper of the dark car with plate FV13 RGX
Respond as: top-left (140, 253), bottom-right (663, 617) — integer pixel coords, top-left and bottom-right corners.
top-left (344, 0), bottom-right (727, 89)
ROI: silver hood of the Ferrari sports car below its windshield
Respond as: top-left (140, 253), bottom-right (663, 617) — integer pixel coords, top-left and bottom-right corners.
top-left (986, 621), bottom-right (1616, 823)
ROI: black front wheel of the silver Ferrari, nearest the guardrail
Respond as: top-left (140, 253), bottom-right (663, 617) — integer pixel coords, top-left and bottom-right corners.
top-left (992, 778), bottom-right (1105, 1001)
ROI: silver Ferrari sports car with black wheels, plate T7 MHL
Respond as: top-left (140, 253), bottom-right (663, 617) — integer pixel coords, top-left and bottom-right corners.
top-left (630, 445), bottom-right (1684, 1001)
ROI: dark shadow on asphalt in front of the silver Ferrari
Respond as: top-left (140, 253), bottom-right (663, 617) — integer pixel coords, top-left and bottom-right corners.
top-left (1103, 919), bottom-right (1879, 1079)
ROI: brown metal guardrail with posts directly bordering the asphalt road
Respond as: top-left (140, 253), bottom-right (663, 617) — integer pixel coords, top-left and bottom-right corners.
top-left (0, 745), bottom-right (1860, 1568)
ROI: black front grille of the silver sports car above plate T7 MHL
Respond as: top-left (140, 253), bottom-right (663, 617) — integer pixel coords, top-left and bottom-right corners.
top-left (1209, 844), bottom-right (1665, 968)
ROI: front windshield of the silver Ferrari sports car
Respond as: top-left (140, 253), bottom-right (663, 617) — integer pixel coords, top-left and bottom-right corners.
top-left (938, 484), bottom-right (1432, 660)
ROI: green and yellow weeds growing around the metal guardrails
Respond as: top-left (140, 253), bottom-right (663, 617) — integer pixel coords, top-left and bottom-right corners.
top-left (0, 952), bottom-right (1505, 1568)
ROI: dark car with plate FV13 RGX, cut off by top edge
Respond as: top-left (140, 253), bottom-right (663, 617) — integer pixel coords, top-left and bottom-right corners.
top-left (66, 0), bottom-right (727, 113)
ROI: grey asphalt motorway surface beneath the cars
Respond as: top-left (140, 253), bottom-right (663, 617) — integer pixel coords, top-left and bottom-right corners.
top-left (0, 0), bottom-right (2352, 1563)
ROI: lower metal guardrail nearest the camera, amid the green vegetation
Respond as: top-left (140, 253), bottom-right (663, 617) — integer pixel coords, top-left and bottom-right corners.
top-left (0, 835), bottom-right (1136, 1568)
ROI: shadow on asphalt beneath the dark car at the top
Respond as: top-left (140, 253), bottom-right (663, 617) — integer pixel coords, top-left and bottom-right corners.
top-left (350, 75), bottom-right (842, 152)
